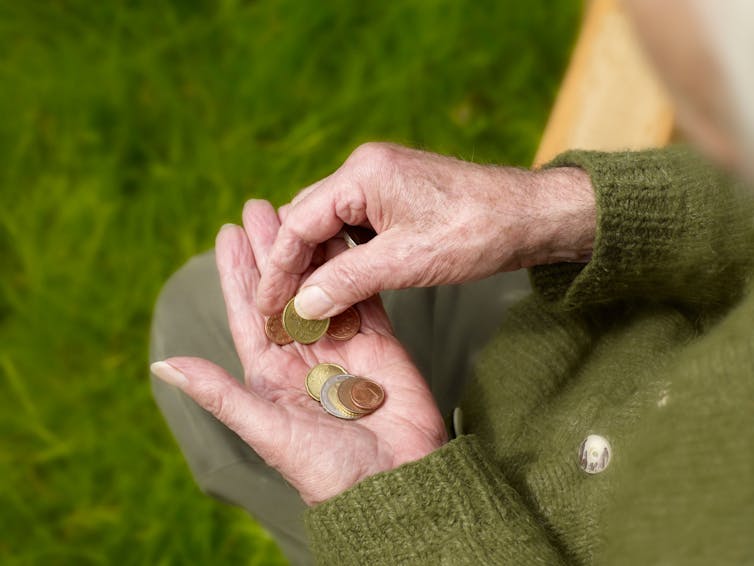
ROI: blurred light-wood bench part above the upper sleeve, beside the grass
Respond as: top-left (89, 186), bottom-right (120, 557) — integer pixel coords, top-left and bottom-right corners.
top-left (534, 0), bottom-right (673, 166)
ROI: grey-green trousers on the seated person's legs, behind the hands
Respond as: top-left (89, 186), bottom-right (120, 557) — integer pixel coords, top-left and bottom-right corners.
top-left (150, 252), bottom-right (529, 565)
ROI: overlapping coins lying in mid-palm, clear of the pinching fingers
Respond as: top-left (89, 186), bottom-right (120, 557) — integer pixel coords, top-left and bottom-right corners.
top-left (306, 363), bottom-right (385, 420)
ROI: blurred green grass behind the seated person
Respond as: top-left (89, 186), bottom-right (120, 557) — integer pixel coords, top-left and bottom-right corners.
top-left (0, 0), bottom-right (581, 564)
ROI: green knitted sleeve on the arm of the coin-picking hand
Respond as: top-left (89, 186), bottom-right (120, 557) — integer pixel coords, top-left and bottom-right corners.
top-left (530, 147), bottom-right (754, 308)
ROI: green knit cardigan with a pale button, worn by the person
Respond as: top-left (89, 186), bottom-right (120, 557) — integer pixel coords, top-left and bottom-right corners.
top-left (306, 148), bottom-right (754, 565)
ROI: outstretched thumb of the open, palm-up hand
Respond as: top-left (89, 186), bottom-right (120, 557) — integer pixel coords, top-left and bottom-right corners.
top-left (150, 357), bottom-right (287, 460)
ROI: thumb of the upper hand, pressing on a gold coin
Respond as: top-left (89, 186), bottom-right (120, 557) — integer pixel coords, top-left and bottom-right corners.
top-left (294, 233), bottom-right (416, 319)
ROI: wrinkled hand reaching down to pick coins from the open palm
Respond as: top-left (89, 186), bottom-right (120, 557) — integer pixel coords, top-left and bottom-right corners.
top-left (257, 143), bottom-right (595, 318)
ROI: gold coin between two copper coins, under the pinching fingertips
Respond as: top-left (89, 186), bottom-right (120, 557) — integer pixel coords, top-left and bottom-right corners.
top-left (264, 299), bottom-right (361, 346)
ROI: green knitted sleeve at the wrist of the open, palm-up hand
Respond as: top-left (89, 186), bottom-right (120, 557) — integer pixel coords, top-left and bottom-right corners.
top-left (306, 435), bottom-right (562, 566)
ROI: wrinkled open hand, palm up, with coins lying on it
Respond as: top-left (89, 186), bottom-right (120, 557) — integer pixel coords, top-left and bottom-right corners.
top-left (153, 201), bottom-right (447, 505)
